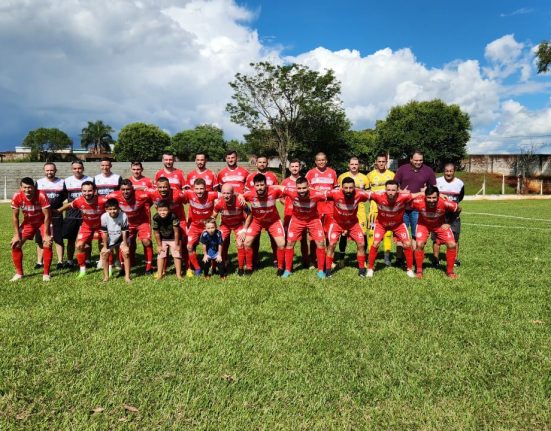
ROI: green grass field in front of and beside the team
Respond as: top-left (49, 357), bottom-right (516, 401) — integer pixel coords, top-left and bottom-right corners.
top-left (0, 201), bottom-right (551, 430)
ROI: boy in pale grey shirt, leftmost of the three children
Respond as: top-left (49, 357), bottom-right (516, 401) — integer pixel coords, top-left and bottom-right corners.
top-left (100, 199), bottom-right (131, 283)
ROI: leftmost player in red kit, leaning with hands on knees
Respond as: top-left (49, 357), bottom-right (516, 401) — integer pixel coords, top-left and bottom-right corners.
top-left (10, 177), bottom-right (52, 281)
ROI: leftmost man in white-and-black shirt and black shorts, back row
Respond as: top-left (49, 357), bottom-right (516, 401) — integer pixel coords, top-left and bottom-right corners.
top-left (35, 162), bottom-right (67, 269)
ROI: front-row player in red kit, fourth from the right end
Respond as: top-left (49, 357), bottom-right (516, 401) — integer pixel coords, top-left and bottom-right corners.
top-left (272, 177), bottom-right (326, 278)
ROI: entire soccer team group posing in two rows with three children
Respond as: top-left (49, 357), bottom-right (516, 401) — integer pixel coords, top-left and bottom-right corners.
top-left (11, 151), bottom-right (464, 282)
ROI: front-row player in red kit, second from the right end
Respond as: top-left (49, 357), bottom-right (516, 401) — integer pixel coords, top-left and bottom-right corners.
top-left (367, 180), bottom-right (419, 277)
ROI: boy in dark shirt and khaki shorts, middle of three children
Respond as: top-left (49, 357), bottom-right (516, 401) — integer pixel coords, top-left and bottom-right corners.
top-left (151, 199), bottom-right (182, 280)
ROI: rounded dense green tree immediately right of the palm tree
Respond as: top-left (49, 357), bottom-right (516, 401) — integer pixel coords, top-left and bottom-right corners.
top-left (115, 123), bottom-right (170, 162)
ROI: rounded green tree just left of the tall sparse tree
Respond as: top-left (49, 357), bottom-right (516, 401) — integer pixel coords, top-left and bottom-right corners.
top-left (170, 124), bottom-right (226, 161)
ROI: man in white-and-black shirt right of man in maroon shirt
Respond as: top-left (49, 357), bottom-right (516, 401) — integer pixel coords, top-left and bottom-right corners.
top-left (432, 163), bottom-right (465, 266)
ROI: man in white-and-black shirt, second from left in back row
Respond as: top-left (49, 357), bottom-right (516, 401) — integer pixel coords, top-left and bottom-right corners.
top-left (63, 160), bottom-right (92, 268)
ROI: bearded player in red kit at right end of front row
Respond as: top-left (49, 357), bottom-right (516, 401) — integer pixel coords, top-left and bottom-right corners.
top-left (411, 185), bottom-right (461, 278)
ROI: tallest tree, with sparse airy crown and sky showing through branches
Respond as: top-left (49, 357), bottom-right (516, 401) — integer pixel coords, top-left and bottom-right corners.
top-left (226, 62), bottom-right (345, 174)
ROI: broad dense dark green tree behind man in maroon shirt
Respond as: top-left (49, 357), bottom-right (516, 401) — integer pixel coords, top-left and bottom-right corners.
top-left (375, 99), bottom-right (471, 169)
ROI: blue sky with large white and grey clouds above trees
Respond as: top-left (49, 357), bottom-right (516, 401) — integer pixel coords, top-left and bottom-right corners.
top-left (0, 0), bottom-right (551, 153)
